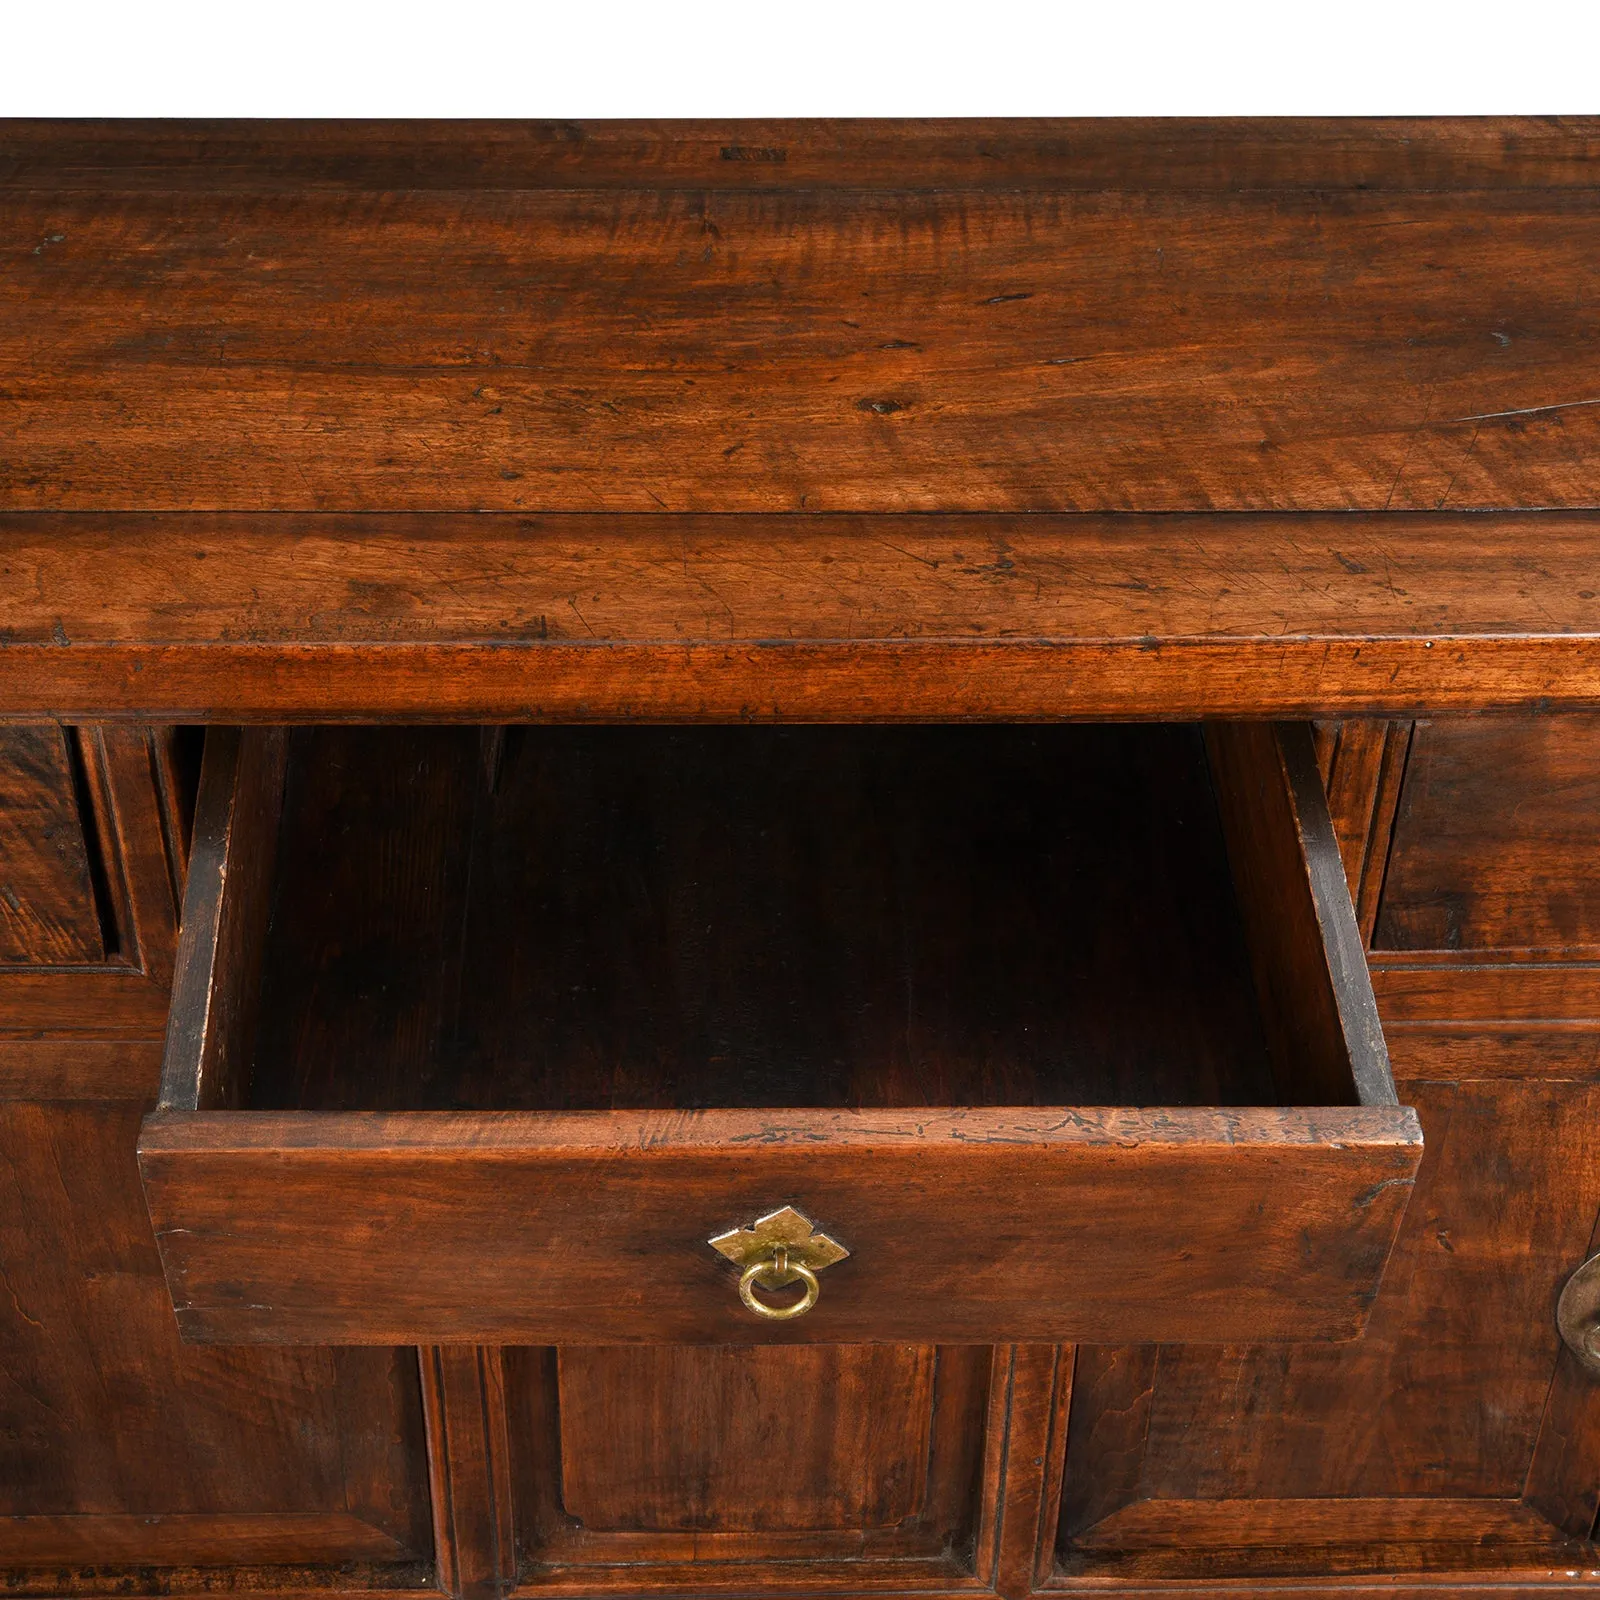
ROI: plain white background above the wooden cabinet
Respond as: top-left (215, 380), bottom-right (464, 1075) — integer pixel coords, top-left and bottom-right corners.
top-left (0, 0), bottom-right (1600, 117)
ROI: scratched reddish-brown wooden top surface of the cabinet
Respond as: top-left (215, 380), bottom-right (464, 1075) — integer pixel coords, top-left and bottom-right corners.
top-left (0, 118), bottom-right (1600, 715)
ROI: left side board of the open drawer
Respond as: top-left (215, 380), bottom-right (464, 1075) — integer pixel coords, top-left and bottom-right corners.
top-left (162, 728), bottom-right (288, 1110)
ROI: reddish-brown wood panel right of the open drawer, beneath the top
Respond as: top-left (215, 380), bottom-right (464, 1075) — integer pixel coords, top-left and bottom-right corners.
top-left (1373, 715), bottom-right (1600, 952)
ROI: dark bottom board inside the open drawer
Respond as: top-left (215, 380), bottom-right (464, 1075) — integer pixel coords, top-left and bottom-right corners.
top-left (246, 728), bottom-right (1273, 1110)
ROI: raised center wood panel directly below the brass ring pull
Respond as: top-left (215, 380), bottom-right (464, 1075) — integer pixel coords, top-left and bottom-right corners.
top-left (560, 1344), bottom-right (936, 1533)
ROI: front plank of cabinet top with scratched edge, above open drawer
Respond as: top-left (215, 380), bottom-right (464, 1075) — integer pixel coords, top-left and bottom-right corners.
top-left (0, 514), bottom-right (1600, 722)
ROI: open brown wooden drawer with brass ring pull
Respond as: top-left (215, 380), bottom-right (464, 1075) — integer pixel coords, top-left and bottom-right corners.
top-left (139, 723), bottom-right (1421, 1344)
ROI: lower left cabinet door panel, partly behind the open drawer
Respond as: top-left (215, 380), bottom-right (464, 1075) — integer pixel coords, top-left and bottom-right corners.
top-left (0, 1102), bottom-right (429, 1566)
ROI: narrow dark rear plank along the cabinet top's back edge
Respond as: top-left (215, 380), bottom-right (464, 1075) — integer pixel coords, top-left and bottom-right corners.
top-left (9, 117), bottom-right (1600, 194)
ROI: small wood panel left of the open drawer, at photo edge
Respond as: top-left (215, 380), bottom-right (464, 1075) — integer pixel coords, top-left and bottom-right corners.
top-left (0, 723), bottom-right (106, 966)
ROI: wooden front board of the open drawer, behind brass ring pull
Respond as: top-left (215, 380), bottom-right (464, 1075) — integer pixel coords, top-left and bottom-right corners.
top-left (141, 1107), bottom-right (1421, 1344)
